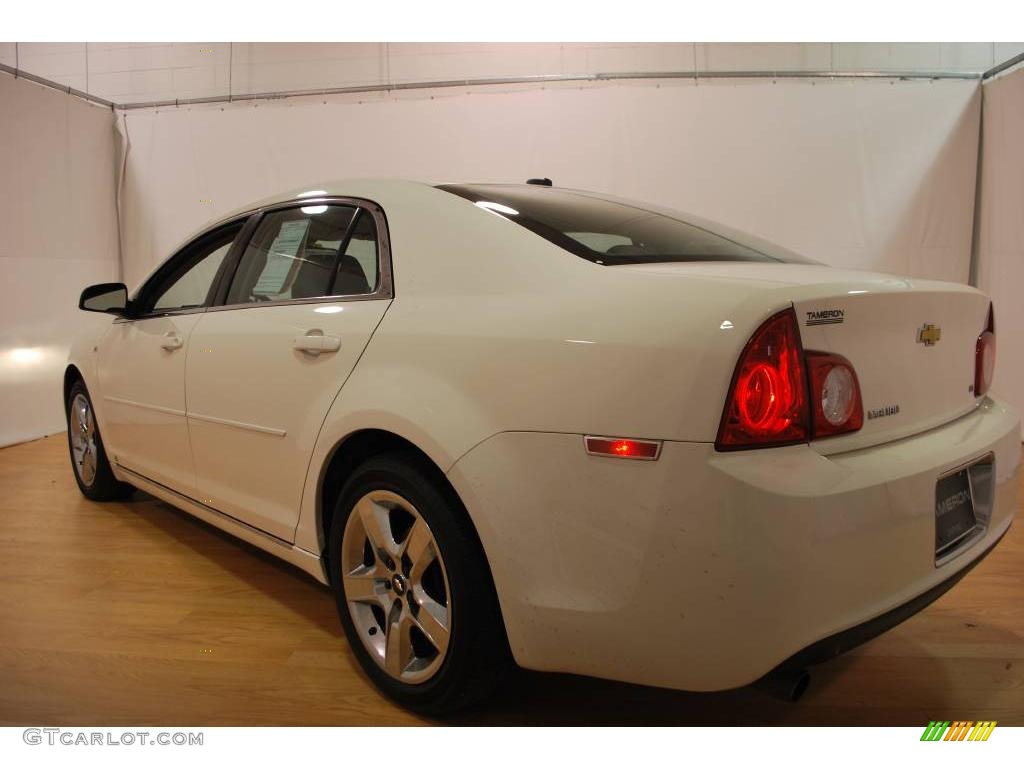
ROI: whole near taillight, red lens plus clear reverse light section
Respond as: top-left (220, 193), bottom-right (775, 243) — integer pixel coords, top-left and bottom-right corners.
top-left (715, 307), bottom-right (864, 451)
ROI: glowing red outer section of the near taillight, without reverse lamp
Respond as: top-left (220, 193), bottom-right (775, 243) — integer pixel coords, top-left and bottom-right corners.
top-left (715, 307), bottom-right (808, 451)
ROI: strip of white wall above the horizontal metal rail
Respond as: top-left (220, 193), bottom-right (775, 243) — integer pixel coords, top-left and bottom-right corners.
top-left (0, 42), bottom-right (1024, 103)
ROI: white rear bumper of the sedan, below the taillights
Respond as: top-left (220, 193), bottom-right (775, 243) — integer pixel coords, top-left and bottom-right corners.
top-left (450, 400), bottom-right (1021, 690)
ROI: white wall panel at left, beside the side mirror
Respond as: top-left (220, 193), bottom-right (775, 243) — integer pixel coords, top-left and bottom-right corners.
top-left (0, 74), bottom-right (118, 445)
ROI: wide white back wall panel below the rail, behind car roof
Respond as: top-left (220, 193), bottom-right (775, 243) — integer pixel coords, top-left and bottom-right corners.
top-left (116, 81), bottom-right (980, 284)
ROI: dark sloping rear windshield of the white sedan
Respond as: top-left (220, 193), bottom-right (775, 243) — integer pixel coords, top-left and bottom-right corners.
top-left (438, 184), bottom-right (796, 265)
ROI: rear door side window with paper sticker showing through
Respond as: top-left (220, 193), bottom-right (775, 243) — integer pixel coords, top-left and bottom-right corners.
top-left (225, 205), bottom-right (378, 305)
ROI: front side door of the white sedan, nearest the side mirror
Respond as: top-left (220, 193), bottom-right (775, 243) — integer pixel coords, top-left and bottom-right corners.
top-left (97, 221), bottom-right (244, 496)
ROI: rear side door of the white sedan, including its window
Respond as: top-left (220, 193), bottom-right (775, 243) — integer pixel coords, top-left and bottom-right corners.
top-left (186, 199), bottom-right (391, 541)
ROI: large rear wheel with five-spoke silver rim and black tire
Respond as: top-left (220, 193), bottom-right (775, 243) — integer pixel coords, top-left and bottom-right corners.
top-left (328, 453), bottom-right (513, 715)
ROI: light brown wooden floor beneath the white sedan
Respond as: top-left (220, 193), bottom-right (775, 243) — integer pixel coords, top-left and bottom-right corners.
top-left (0, 435), bottom-right (1024, 727)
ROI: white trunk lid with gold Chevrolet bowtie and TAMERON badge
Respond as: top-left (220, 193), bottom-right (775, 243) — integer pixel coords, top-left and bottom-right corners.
top-left (613, 262), bottom-right (989, 455)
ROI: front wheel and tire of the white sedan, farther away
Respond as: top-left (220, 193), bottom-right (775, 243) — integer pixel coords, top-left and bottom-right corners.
top-left (65, 379), bottom-right (134, 502)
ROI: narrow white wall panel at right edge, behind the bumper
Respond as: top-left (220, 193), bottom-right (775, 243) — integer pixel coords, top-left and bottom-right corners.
top-left (978, 69), bottom-right (1024, 421)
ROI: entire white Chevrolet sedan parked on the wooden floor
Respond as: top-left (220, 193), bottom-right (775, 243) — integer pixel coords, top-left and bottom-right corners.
top-left (65, 180), bottom-right (1021, 712)
